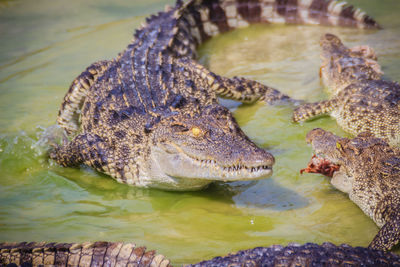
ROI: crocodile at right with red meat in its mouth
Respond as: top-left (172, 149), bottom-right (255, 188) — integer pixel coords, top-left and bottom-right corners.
top-left (306, 128), bottom-right (400, 250)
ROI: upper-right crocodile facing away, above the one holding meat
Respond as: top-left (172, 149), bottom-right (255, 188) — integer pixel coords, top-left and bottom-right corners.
top-left (293, 34), bottom-right (400, 145)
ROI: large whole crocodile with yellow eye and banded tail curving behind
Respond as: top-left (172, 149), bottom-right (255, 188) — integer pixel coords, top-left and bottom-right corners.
top-left (49, 0), bottom-right (379, 190)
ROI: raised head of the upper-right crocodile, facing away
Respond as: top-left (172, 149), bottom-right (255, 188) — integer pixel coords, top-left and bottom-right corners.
top-left (320, 33), bottom-right (383, 94)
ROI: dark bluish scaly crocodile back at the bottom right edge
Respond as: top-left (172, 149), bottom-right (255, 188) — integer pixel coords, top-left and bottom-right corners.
top-left (188, 243), bottom-right (400, 267)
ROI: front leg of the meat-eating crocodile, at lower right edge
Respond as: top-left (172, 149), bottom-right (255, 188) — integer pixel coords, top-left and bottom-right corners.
top-left (368, 213), bottom-right (400, 251)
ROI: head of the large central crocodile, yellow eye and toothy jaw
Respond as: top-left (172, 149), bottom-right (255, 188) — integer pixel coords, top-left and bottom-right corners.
top-left (148, 105), bottom-right (274, 190)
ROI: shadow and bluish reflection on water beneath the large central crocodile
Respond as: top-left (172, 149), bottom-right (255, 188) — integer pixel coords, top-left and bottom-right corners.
top-left (56, 167), bottom-right (309, 211)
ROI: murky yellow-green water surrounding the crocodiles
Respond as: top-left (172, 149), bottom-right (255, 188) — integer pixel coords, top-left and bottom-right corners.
top-left (0, 0), bottom-right (400, 264)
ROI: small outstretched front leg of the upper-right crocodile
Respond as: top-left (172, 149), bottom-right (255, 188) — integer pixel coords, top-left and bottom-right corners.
top-left (292, 98), bottom-right (337, 122)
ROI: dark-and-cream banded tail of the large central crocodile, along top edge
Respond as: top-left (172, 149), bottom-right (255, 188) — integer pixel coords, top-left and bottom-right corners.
top-left (176, 0), bottom-right (380, 44)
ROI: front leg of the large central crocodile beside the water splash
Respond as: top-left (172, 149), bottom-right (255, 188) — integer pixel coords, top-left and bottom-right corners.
top-left (50, 133), bottom-right (110, 173)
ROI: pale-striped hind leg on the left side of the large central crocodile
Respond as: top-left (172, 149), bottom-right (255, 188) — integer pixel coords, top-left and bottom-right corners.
top-left (57, 61), bottom-right (110, 136)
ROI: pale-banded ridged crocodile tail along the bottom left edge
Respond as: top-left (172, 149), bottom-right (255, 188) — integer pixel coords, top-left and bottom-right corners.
top-left (0, 242), bottom-right (170, 267)
